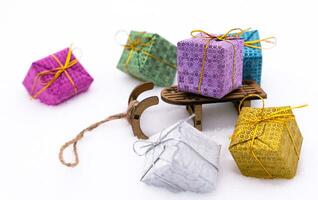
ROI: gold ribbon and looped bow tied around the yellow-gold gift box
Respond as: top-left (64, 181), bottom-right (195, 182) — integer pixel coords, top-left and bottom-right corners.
top-left (230, 94), bottom-right (308, 178)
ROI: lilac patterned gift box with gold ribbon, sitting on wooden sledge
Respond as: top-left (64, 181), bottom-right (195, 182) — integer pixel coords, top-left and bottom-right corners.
top-left (177, 31), bottom-right (244, 98)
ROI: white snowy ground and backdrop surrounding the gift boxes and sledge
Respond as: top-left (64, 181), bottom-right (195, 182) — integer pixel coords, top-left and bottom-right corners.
top-left (0, 0), bottom-right (318, 200)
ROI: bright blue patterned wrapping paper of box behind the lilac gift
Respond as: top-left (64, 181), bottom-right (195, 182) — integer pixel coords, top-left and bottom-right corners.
top-left (241, 30), bottom-right (262, 84)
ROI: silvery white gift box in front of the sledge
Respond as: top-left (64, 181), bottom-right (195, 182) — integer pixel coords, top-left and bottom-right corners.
top-left (141, 117), bottom-right (221, 193)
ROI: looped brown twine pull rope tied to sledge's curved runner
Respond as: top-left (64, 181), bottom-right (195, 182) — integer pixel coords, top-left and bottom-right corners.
top-left (59, 100), bottom-right (139, 167)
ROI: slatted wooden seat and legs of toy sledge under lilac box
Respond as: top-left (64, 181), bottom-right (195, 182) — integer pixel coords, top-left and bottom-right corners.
top-left (161, 81), bottom-right (267, 131)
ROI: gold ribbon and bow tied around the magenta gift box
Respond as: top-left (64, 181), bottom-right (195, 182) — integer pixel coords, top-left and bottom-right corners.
top-left (31, 48), bottom-right (77, 99)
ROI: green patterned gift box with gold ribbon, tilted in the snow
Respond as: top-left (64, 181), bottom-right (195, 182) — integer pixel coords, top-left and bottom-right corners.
top-left (117, 31), bottom-right (176, 86)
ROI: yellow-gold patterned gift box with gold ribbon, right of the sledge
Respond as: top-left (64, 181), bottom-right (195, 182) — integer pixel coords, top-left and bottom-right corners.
top-left (229, 95), bottom-right (306, 179)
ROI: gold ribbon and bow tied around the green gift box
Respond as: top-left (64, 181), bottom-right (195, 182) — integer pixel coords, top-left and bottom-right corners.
top-left (123, 32), bottom-right (176, 73)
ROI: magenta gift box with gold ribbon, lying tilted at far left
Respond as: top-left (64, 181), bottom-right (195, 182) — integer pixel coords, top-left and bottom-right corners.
top-left (23, 48), bottom-right (93, 105)
